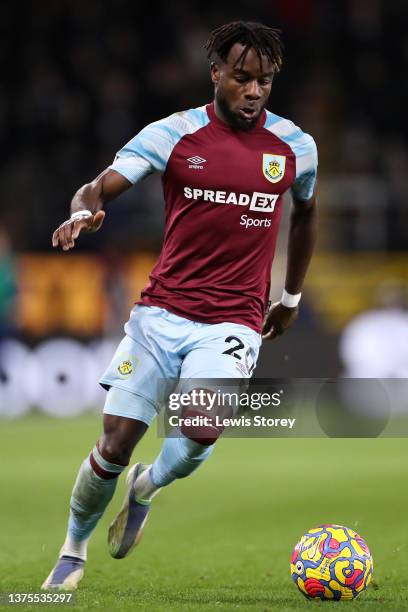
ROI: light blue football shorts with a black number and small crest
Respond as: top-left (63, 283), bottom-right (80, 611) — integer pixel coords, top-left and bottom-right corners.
top-left (99, 305), bottom-right (261, 425)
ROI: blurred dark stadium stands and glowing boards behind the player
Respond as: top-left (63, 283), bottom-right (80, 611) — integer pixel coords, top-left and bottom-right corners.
top-left (0, 0), bottom-right (408, 416)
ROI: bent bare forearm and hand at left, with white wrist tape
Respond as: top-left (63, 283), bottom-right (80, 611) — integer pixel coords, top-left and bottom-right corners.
top-left (52, 168), bottom-right (132, 251)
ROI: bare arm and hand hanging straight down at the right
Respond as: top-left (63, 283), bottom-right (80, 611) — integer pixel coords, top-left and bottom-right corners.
top-left (262, 193), bottom-right (317, 340)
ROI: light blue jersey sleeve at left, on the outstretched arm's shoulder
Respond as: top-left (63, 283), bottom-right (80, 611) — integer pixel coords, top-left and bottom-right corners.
top-left (109, 107), bottom-right (209, 184)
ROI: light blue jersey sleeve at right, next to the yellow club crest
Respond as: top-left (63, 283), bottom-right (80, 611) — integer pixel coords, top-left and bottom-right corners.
top-left (291, 132), bottom-right (318, 202)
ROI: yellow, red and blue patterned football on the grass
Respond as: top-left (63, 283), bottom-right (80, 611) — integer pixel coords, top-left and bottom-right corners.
top-left (290, 525), bottom-right (373, 600)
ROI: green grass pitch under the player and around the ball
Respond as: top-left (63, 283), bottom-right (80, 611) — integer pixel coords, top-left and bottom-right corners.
top-left (0, 415), bottom-right (408, 612)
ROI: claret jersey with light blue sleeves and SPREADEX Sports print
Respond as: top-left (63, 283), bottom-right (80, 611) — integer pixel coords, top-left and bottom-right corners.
top-left (110, 104), bottom-right (317, 332)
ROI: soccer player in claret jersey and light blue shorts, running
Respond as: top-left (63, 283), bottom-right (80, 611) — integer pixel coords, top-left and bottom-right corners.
top-left (43, 21), bottom-right (317, 589)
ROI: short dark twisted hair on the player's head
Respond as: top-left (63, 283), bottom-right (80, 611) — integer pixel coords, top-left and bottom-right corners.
top-left (204, 21), bottom-right (283, 72)
